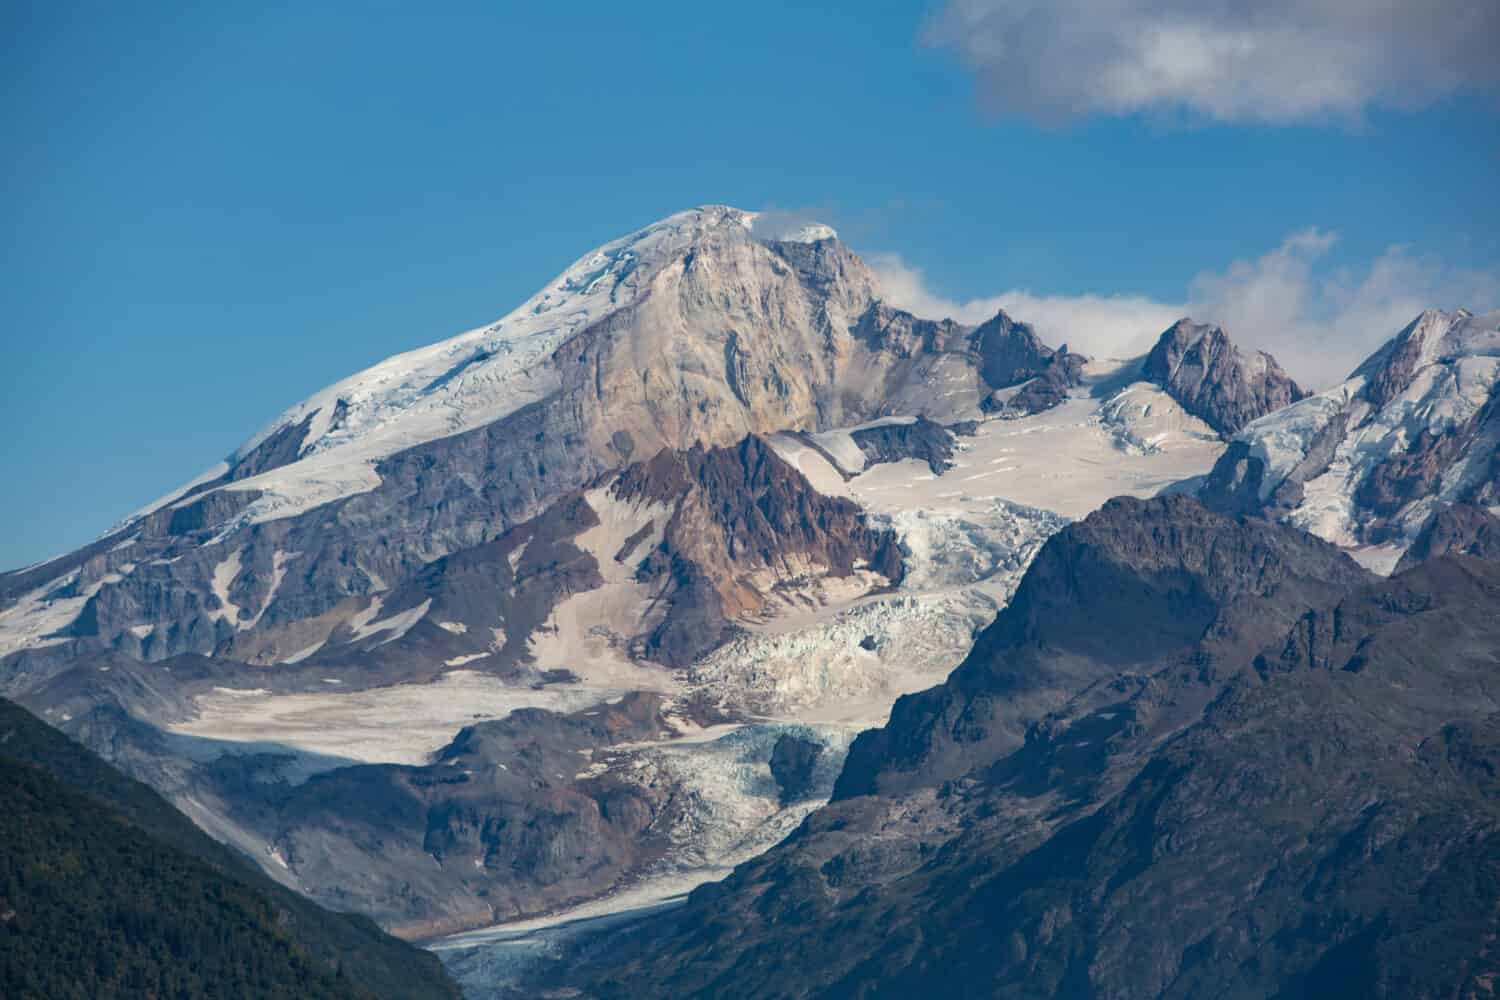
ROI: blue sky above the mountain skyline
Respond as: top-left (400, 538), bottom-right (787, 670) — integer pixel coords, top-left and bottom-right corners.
top-left (0, 0), bottom-right (1500, 567)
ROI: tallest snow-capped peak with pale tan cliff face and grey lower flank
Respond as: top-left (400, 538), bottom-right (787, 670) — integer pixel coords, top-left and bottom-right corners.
top-left (0, 207), bottom-right (1086, 680)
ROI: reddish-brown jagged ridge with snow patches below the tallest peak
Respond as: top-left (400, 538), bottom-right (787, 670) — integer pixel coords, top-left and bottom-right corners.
top-left (6, 429), bottom-right (900, 701)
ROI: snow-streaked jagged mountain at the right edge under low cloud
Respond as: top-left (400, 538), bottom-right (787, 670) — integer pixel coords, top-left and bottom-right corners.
top-left (1200, 310), bottom-right (1500, 571)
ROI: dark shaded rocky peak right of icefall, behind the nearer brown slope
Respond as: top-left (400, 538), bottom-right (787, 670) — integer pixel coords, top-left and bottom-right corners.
top-left (834, 496), bottom-right (1365, 799)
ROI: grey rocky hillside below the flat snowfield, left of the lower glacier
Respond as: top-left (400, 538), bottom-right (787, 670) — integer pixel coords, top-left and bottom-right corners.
top-left (202, 694), bottom-right (671, 936)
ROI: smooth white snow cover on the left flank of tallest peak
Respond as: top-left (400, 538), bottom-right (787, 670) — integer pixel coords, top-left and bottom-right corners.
top-left (130, 205), bottom-right (837, 528)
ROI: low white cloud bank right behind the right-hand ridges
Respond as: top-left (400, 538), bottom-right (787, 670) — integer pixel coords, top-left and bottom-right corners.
top-left (867, 235), bottom-right (1500, 388)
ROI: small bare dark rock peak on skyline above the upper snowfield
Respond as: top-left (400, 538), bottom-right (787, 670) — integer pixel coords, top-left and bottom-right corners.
top-left (1142, 319), bottom-right (1307, 438)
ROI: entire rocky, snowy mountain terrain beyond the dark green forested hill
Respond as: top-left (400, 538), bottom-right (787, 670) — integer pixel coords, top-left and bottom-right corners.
top-left (0, 205), bottom-right (1500, 997)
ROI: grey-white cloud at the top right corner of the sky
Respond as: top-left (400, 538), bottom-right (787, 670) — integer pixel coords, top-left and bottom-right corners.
top-left (926, 0), bottom-right (1500, 123)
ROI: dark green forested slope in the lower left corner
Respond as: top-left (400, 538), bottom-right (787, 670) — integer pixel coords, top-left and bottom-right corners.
top-left (0, 700), bottom-right (458, 1000)
